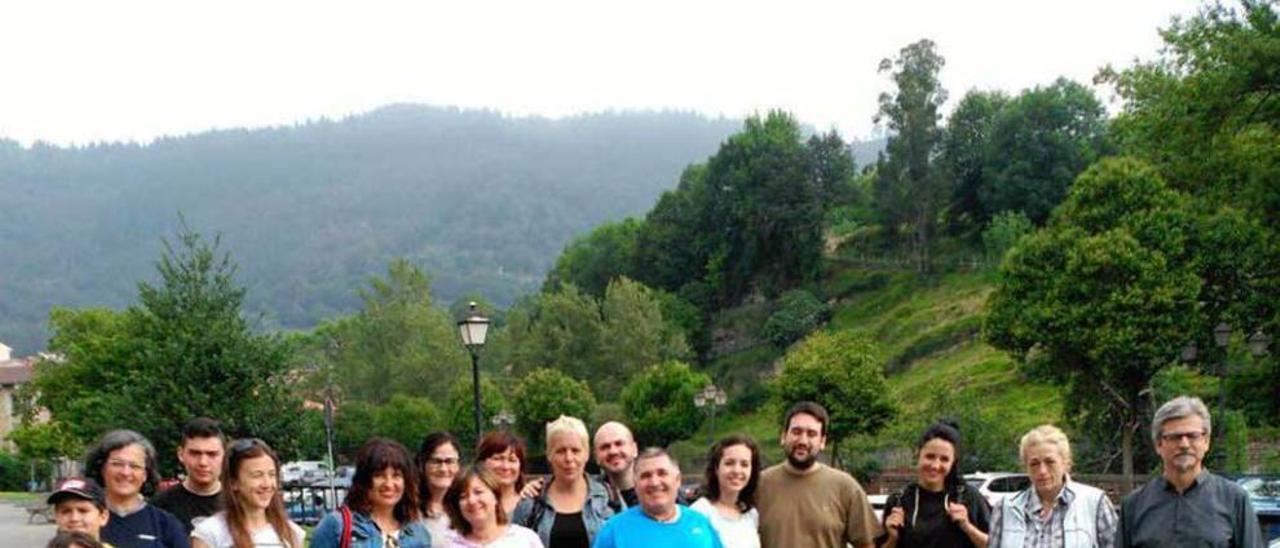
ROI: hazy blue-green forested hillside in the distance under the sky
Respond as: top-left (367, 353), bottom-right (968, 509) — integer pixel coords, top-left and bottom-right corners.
top-left (0, 105), bottom-right (740, 353)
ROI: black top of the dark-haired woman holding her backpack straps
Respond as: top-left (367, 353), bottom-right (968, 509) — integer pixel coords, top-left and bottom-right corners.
top-left (877, 484), bottom-right (991, 548)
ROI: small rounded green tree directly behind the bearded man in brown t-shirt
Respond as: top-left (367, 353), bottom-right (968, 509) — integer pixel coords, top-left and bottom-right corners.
top-left (771, 330), bottom-right (896, 463)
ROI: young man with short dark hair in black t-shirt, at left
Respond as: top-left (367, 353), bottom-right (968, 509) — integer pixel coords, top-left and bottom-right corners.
top-left (151, 417), bottom-right (227, 535)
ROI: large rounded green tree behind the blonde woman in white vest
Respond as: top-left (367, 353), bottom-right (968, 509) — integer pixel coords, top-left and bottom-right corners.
top-left (984, 159), bottom-right (1201, 486)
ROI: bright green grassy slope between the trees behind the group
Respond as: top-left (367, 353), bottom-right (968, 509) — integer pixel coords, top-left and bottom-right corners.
top-left (672, 265), bottom-right (1061, 467)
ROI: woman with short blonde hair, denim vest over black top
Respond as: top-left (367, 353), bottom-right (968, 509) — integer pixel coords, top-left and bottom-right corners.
top-left (511, 415), bottom-right (613, 548)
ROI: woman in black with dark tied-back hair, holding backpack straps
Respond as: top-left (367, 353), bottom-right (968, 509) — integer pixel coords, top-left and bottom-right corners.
top-left (876, 421), bottom-right (991, 548)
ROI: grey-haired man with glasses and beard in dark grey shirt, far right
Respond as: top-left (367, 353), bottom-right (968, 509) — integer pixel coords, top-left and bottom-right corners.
top-left (1119, 396), bottom-right (1263, 548)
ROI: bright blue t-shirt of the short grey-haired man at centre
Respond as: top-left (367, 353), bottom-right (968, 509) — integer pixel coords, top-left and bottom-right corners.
top-left (591, 506), bottom-right (724, 548)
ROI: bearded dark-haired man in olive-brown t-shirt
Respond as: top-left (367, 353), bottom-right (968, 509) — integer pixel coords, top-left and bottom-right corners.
top-left (756, 402), bottom-right (879, 548)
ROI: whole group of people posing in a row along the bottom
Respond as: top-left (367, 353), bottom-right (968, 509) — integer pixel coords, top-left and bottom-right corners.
top-left (49, 397), bottom-right (1262, 548)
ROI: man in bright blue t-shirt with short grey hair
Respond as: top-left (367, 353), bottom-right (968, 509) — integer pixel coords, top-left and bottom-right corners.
top-left (591, 447), bottom-right (723, 548)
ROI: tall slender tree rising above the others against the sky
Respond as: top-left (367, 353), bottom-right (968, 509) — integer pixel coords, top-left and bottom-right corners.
top-left (874, 40), bottom-right (950, 273)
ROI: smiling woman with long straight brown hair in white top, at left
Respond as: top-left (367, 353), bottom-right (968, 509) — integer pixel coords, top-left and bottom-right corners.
top-left (191, 438), bottom-right (305, 548)
